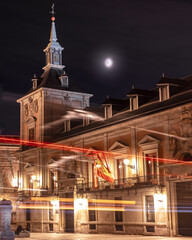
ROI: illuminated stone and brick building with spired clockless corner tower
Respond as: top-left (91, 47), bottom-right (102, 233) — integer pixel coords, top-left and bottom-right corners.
top-left (11, 9), bottom-right (192, 235)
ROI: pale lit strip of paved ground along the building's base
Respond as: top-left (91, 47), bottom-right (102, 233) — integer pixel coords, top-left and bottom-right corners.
top-left (16, 233), bottom-right (192, 240)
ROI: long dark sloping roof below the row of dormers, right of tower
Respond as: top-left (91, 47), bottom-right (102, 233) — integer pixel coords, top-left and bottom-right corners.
top-left (53, 77), bottom-right (192, 141)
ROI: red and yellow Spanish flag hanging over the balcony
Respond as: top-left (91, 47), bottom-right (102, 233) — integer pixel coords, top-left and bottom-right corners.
top-left (96, 154), bottom-right (114, 183)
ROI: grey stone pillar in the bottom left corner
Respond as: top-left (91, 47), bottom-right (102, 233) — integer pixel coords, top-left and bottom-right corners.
top-left (0, 200), bottom-right (15, 240)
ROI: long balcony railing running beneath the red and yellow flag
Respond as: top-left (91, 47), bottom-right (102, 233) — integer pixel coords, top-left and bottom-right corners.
top-left (76, 175), bottom-right (165, 192)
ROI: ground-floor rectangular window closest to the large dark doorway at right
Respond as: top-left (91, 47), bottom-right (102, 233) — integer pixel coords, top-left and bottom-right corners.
top-left (145, 195), bottom-right (155, 222)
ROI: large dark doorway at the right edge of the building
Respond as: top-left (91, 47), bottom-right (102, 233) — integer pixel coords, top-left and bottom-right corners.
top-left (176, 181), bottom-right (192, 236)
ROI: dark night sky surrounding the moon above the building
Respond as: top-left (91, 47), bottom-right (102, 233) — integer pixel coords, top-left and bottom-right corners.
top-left (0, 0), bottom-right (192, 134)
